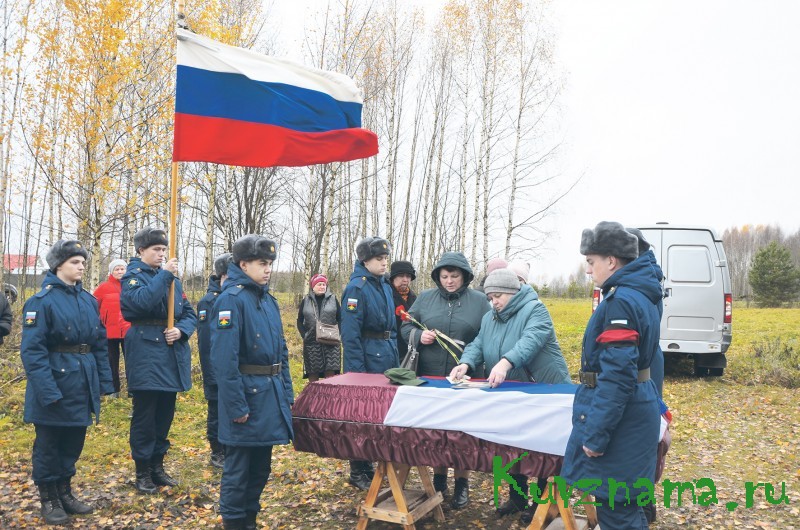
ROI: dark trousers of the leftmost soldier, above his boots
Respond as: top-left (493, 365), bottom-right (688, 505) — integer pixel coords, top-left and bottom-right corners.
top-left (31, 424), bottom-right (86, 484)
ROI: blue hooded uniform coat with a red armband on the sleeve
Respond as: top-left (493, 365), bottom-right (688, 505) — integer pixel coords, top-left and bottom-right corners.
top-left (562, 255), bottom-right (661, 502)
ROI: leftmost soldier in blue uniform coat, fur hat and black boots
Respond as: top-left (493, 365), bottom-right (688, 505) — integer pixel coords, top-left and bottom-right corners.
top-left (20, 240), bottom-right (114, 524)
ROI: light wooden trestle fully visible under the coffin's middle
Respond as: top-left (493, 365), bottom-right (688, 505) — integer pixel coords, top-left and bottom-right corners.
top-left (356, 462), bottom-right (444, 530)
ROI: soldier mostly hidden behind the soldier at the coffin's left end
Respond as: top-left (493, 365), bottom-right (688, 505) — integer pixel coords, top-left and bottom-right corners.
top-left (197, 252), bottom-right (231, 468)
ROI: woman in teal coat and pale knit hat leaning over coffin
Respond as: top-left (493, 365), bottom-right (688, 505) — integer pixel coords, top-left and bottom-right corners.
top-left (450, 269), bottom-right (571, 522)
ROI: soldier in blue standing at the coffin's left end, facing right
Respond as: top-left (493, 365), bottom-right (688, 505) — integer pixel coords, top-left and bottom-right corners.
top-left (209, 235), bottom-right (294, 529)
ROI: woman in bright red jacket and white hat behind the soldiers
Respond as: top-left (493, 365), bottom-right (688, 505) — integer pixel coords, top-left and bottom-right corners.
top-left (94, 259), bottom-right (131, 397)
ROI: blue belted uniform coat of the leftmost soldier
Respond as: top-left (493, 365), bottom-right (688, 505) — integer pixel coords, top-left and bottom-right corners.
top-left (20, 272), bottom-right (114, 427)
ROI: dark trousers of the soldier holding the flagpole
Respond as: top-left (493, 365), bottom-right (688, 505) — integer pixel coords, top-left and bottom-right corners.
top-left (130, 390), bottom-right (177, 460)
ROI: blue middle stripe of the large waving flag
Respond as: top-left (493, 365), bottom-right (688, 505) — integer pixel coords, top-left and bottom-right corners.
top-left (175, 65), bottom-right (361, 132)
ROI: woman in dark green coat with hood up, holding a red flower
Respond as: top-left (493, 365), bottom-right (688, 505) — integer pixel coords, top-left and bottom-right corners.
top-left (400, 252), bottom-right (490, 508)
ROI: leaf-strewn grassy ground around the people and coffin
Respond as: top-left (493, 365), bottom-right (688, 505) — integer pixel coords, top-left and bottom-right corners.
top-left (0, 296), bottom-right (800, 530)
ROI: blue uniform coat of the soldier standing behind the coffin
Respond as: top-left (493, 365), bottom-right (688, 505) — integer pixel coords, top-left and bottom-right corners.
top-left (341, 261), bottom-right (400, 374)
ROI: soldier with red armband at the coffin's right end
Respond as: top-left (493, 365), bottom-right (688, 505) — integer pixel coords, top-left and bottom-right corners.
top-left (561, 222), bottom-right (662, 530)
